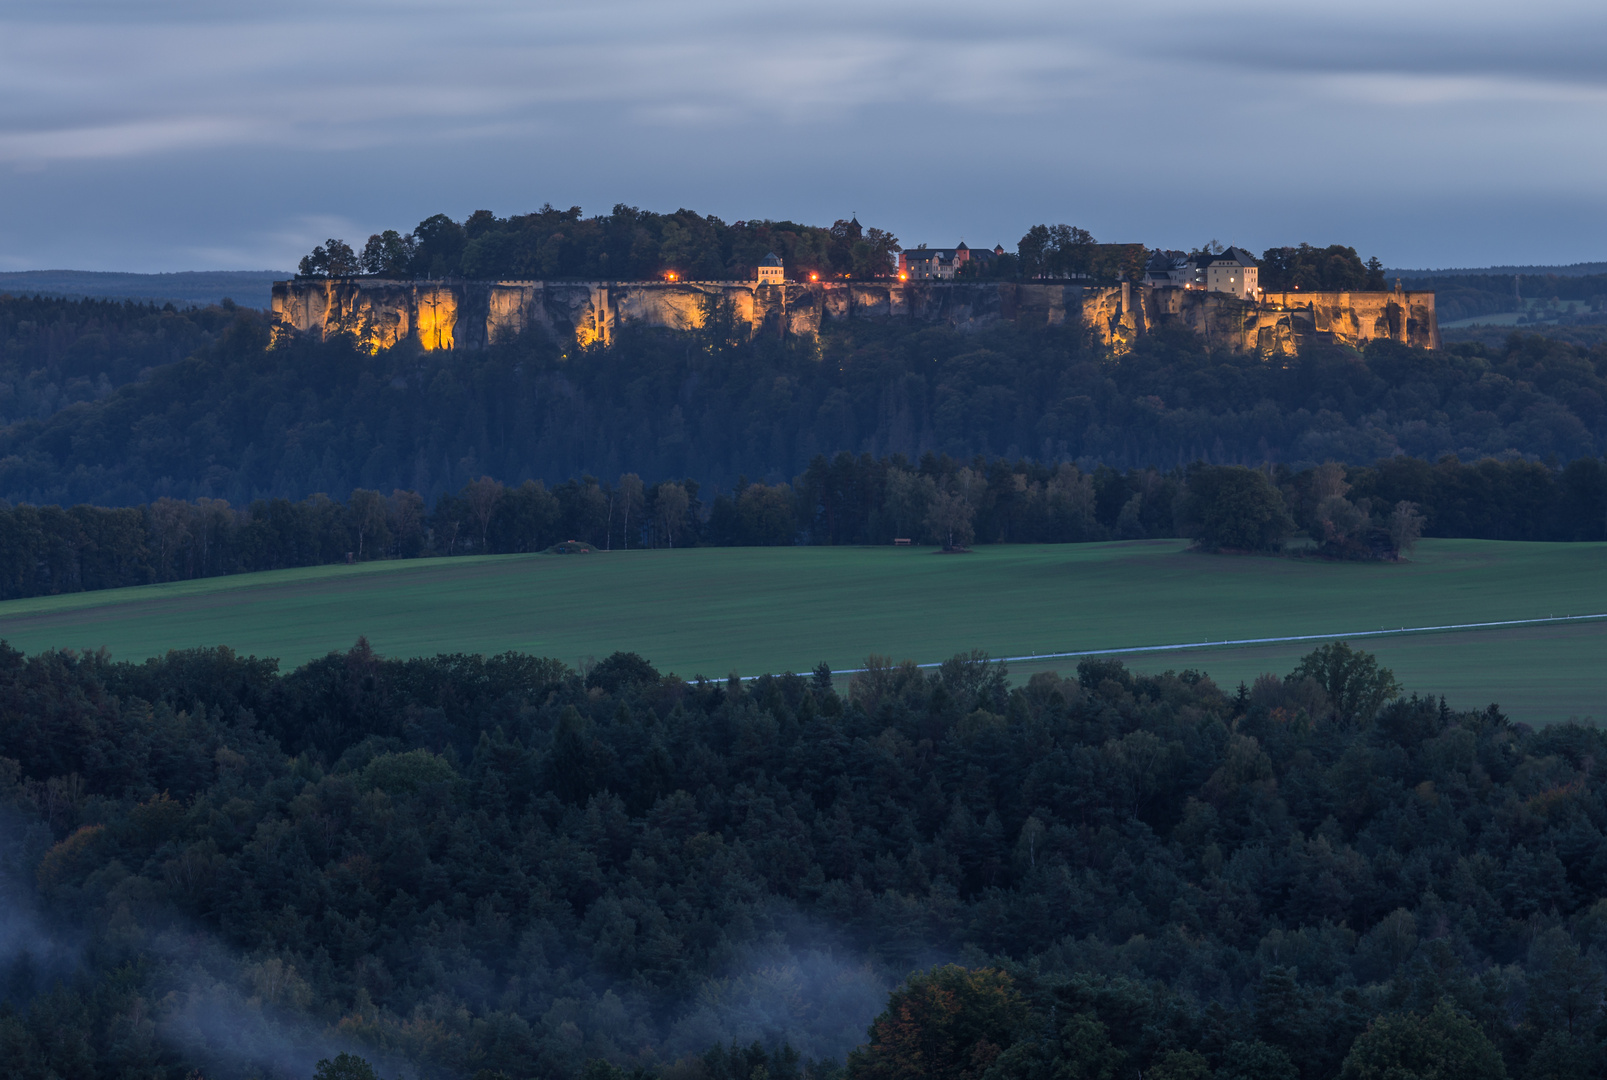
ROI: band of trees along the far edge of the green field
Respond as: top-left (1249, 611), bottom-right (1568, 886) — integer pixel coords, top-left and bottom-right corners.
top-left (0, 453), bottom-right (1607, 599)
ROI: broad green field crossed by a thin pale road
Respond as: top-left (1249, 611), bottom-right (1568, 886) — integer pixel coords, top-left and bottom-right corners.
top-left (0, 540), bottom-right (1607, 722)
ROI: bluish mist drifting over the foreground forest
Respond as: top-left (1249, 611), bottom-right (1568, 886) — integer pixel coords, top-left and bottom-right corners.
top-left (0, 810), bottom-right (899, 1080)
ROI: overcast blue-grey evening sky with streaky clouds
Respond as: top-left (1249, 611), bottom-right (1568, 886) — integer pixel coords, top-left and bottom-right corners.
top-left (0, 0), bottom-right (1607, 272)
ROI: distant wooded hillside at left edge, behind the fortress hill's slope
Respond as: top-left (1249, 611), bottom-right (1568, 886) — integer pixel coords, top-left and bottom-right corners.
top-left (0, 294), bottom-right (235, 426)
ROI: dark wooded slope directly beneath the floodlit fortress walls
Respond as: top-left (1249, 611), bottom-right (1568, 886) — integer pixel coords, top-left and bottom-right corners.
top-left (0, 290), bottom-right (1607, 506)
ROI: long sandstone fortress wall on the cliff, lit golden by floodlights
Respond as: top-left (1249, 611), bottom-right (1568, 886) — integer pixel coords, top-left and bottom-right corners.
top-left (273, 278), bottom-right (1440, 357)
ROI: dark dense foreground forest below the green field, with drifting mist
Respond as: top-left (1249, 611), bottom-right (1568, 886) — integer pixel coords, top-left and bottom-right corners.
top-left (0, 643), bottom-right (1607, 1080)
